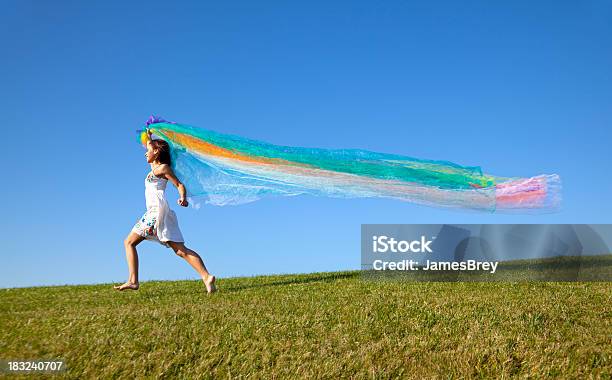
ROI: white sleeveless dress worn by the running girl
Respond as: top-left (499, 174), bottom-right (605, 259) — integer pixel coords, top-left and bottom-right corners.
top-left (132, 166), bottom-right (185, 247)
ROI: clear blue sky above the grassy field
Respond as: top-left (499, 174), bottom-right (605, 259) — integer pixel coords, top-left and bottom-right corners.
top-left (0, 0), bottom-right (612, 287)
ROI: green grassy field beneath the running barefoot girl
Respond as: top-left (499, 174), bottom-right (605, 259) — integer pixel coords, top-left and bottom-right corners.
top-left (0, 255), bottom-right (612, 379)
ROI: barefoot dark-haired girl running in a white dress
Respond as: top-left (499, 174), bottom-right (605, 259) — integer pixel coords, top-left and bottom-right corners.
top-left (114, 133), bottom-right (216, 293)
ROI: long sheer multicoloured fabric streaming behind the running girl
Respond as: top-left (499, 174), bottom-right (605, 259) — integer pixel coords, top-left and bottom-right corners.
top-left (141, 117), bottom-right (561, 212)
